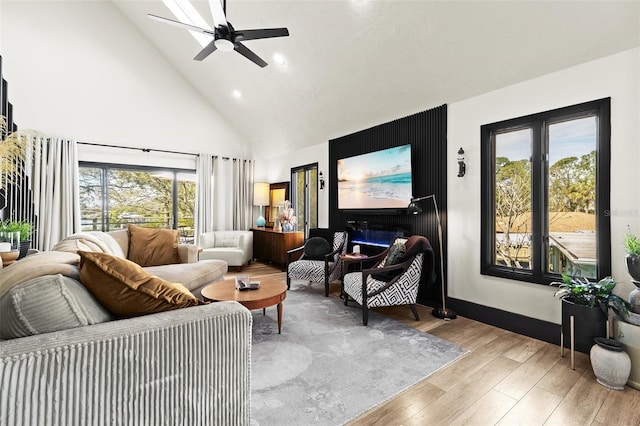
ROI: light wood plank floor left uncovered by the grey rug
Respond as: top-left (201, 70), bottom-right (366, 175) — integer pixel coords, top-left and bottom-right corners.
top-left (227, 262), bottom-right (640, 426)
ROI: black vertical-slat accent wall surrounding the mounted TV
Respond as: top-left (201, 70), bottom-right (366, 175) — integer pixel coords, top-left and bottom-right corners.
top-left (327, 105), bottom-right (447, 306)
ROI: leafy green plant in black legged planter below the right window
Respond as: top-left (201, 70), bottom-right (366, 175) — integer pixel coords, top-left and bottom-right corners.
top-left (551, 275), bottom-right (629, 353)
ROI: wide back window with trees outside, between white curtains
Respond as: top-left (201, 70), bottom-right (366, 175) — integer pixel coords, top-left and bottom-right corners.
top-left (79, 163), bottom-right (196, 242)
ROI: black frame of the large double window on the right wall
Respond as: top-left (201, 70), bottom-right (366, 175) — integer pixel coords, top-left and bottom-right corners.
top-left (480, 98), bottom-right (611, 285)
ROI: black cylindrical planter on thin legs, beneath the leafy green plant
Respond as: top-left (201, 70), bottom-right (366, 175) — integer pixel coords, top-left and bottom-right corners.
top-left (562, 299), bottom-right (607, 354)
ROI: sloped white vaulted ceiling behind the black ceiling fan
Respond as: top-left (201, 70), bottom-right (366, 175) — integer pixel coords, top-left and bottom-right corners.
top-left (112, 0), bottom-right (640, 158)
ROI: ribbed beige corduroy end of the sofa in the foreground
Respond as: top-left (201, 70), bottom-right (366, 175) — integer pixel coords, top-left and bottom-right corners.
top-left (0, 302), bottom-right (252, 425)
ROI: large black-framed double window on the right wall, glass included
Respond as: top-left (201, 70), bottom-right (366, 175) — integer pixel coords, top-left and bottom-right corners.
top-left (481, 98), bottom-right (611, 284)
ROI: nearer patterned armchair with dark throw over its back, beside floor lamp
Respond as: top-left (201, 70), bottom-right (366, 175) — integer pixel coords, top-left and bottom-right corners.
top-left (343, 235), bottom-right (434, 325)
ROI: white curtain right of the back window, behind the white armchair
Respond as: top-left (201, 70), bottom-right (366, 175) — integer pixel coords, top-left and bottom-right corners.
top-left (195, 154), bottom-right (253, 235)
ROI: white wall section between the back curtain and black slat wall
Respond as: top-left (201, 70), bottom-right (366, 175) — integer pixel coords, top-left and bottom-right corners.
top-left (254, 142), bottom-right (329, 228)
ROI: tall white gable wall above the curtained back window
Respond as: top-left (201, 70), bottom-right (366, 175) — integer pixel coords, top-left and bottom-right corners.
top-left (0, 0), bottom-right (250, 167)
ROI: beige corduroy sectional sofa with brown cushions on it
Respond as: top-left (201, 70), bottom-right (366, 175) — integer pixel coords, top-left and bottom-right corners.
top-left (0, 230), bottom-right (252, 426)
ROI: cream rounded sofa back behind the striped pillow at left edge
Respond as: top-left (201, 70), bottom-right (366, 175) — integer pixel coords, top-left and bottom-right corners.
top-left (0, 251), bottom-right (80, 298)
